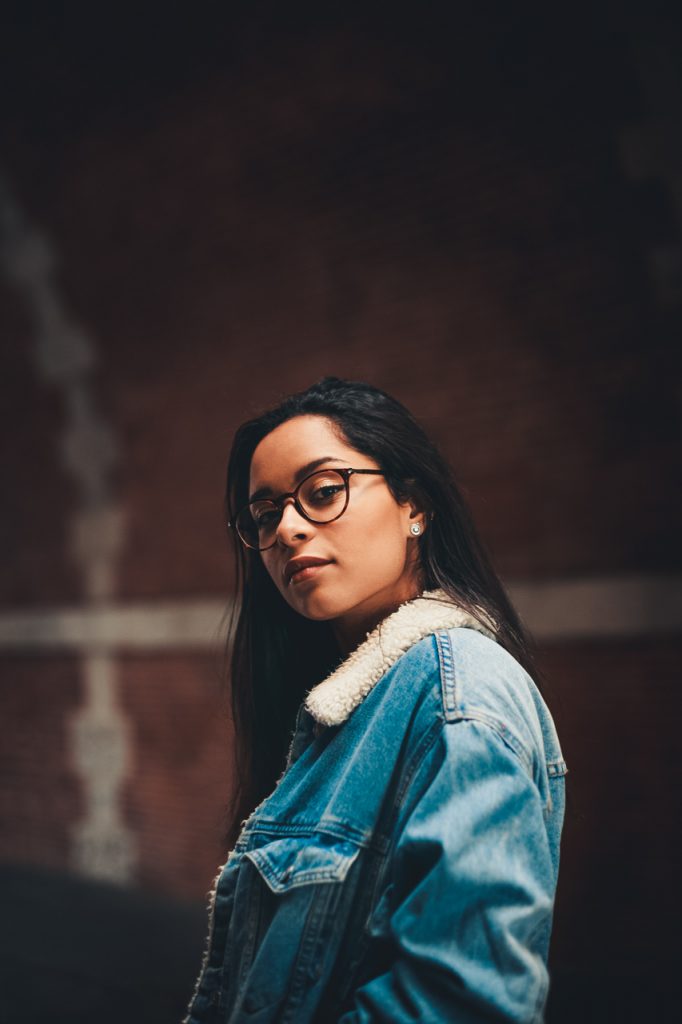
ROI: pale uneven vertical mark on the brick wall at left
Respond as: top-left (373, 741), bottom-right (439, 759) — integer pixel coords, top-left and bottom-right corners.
top-left (0, 172), bottom-right (135, 882)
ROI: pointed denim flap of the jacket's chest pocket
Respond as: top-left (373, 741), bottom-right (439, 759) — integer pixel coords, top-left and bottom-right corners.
top-left (245, 835), bottom-right (359, 893)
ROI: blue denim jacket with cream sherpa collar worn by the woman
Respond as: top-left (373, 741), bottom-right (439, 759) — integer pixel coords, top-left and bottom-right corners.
top-left (184, 591), bottom-right (566, 1024)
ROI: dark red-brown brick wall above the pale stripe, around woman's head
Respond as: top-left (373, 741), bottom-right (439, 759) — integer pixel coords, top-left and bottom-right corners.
top-left (1, 9), bottom-right (677, 602)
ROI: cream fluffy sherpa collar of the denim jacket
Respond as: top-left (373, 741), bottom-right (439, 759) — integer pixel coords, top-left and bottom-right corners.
top-left (305, 590), bottom-right (495, 725)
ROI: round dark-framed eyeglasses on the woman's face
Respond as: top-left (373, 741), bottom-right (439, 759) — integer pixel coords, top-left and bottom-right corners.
top-left (229, 469), bottom-right (384, 551)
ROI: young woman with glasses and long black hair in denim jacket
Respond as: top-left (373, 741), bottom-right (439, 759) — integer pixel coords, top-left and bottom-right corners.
top-left (185, 378), bottom-right (566, 1024)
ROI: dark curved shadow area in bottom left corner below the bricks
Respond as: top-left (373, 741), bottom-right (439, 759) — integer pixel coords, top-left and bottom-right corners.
top-left (0, 865), bottom-right (207, 1024)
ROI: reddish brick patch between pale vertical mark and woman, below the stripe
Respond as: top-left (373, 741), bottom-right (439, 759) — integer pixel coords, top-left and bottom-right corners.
top-left (119, 655), bottom-right (231, 900)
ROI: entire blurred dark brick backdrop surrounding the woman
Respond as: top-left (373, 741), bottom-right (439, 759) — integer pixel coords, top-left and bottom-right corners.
top-left (0, 2), bottom-right (682, 1024)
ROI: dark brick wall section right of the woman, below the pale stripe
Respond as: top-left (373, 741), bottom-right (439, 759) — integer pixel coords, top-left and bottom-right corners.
top-left (541, 638), bottom-right (682, 988)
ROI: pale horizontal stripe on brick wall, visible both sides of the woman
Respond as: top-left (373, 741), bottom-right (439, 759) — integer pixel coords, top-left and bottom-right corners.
top-left (0, 575), bottom-right (682, 654)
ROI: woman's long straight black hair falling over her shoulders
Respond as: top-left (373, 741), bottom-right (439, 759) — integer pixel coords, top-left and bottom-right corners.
top-left (225, 377), bottom-right (537, 843)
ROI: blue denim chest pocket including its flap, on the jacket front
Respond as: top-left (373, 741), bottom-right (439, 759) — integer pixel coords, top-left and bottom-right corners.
top-left (229, 834), bottom-right (360, 1022)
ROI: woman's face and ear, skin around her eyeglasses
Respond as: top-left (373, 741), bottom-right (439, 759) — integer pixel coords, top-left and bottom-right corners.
top-left (249, 416), bottom-right (425, 649)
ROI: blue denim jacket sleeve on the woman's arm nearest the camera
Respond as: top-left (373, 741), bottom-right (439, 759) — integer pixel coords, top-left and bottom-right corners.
top-left (339, 719), bottom-right (556, 1024)
